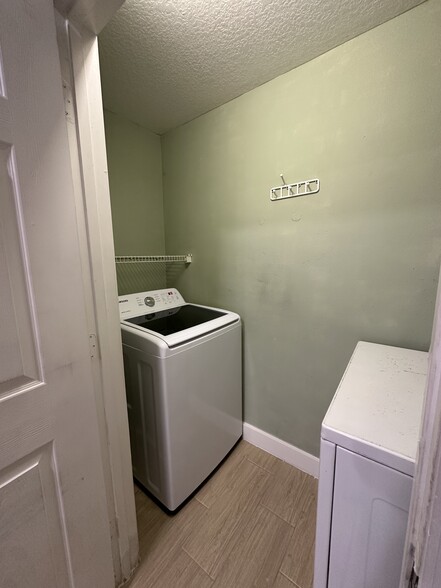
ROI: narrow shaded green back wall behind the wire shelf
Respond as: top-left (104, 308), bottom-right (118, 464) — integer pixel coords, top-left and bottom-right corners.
top-left (104, 110), bottom-right (166, 294)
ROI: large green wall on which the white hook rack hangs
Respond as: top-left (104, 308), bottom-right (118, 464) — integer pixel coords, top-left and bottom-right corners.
top-left (162, 0), bottom-right (441, 454)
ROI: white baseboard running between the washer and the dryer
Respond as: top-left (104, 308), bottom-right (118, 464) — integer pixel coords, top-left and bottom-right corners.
top-left (243, 423), bottom-right (319, 478)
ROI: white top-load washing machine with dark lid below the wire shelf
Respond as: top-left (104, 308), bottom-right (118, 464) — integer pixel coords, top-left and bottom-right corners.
top-left (119, 288), bottom-right (242, 511)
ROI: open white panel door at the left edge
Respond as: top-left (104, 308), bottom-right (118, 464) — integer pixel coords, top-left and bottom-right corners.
top-left (0, 0), bottom-right (114, 588)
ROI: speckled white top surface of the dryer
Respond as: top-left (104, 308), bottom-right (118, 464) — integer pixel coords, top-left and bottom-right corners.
top-left (322, 341), bottom-right (428, 475)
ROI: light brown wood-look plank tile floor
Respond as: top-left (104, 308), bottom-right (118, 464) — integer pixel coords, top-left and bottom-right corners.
top-left (130, 441), bottom-right (317, 588)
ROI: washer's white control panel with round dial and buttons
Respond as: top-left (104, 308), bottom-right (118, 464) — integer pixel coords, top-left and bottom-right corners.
top-left (118, 288), bottom-right (185, 320)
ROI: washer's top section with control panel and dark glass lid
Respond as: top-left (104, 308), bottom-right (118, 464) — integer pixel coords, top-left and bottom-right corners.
top-left (119, 288), bottom-right (240, 348)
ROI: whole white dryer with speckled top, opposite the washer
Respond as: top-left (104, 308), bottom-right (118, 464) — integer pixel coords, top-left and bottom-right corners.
top-left (314, 341), bottom-right (427, 588)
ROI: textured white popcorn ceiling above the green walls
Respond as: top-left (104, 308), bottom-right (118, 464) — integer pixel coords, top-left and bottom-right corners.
top-left (99, 0), bottom-right (422, 133)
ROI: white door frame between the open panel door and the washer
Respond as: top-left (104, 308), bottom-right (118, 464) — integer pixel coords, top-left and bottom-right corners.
top-left (54, 0), bottom-right (138, 586)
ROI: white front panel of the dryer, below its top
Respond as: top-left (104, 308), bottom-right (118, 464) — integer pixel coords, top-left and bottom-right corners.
top-left (328, 447), bottom-right (412, 588)
